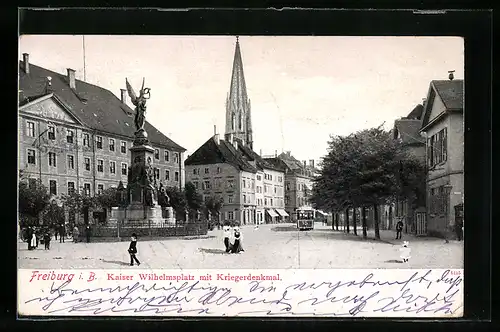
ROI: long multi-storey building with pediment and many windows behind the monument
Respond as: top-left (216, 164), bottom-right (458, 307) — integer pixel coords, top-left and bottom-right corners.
top-left (18, 54), bottom-right (185, 195)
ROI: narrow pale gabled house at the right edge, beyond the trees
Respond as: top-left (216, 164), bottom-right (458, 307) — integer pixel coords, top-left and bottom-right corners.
top-left (420, 75), bottom-right (464, 237)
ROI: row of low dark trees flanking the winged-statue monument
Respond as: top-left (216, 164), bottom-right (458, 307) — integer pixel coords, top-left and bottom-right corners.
top-left (19, 172), bottom-right (223, 227)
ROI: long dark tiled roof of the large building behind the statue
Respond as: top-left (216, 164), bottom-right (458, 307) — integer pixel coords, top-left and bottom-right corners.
top-left (19, 62), bottom-right (186, 152)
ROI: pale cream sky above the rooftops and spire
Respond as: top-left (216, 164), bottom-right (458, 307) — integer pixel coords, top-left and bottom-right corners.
top-left (19, 35), bottom-right (464, 161)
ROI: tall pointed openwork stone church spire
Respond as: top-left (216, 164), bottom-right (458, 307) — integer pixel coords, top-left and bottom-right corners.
top-left (225, 37), bottom-right (253, 149)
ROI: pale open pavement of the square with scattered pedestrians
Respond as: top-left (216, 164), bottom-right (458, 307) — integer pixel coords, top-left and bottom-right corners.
top-left (18, 223), bottom-right (464, 269)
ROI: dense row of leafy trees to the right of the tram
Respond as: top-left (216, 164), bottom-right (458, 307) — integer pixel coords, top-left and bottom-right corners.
top-left (311, 126), bottom-right (426, 239)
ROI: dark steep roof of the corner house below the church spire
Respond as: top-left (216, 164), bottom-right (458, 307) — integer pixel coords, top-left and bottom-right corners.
top-left (184, 137), bottom-right (257, 173)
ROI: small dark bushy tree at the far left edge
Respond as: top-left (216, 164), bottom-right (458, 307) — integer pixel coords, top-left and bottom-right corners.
top-left (18, 180), bottom-right (50, 224)
